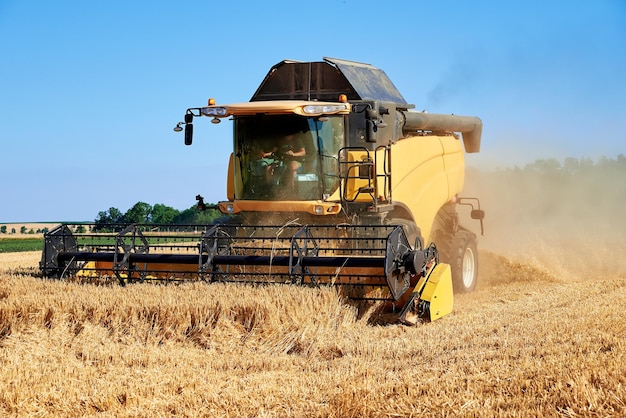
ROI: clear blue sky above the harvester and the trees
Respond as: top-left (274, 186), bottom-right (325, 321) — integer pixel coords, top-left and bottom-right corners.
top-left (0, 0), bottom-right (626, 223)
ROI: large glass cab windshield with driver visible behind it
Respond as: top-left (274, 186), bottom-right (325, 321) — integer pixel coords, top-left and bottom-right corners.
top-left (234, 115), bottom-right (344, 200)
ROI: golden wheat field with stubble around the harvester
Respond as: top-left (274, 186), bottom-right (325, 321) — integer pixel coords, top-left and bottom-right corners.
top-left (0, 247), bottom-right (626, 417)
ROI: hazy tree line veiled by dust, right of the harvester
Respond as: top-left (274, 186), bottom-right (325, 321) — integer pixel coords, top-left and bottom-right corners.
top-left (466, 154), bottom-right (626, 237)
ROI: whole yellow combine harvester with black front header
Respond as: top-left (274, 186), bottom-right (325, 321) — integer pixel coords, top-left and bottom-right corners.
top-left (40, 58), bottom-right (484, 324)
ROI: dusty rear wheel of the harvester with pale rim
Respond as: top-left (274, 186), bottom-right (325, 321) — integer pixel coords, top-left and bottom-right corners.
top-left (439, 229), bottom-right (478, 293)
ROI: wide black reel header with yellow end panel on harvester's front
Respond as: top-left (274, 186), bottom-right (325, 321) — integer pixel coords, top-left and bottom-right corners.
top-left (40, 223), bottom-right (452, 323)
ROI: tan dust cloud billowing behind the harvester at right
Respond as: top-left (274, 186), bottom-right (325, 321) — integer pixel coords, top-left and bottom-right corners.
top-left (461, 155), bottom-right (626, 281)
